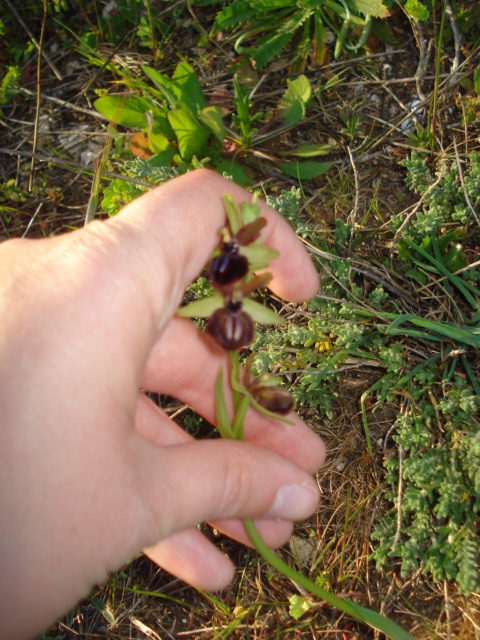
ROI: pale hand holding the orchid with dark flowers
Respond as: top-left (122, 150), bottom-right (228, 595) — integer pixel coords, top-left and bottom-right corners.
top-left (0, 170), bottom-right (325, 640)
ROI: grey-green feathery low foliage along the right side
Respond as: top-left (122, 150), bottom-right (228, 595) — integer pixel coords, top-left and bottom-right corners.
top-left (252, 152), bottom-right (480, 594)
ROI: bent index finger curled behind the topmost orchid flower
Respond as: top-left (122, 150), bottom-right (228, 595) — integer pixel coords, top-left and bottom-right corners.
top-left (112, 169), bottom-right (318, 302)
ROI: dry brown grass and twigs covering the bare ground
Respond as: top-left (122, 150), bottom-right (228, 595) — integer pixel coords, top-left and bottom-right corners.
top-left (0, 2), bottom-right (480, 640)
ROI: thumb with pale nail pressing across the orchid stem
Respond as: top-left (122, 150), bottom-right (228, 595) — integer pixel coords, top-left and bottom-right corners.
top-left (134, 439), bottom-right (319, 546)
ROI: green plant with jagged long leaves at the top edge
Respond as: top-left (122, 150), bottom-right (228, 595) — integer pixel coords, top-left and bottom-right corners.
top-left (202, 0), bottom-right (388, 69)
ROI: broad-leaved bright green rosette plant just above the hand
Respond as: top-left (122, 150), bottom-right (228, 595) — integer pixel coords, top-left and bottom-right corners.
top-left (95, 60), bottom-right (332, 215)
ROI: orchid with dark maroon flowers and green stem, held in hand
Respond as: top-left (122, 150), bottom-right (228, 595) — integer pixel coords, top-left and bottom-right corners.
top-left (178, 196), bottom-right (412, 640)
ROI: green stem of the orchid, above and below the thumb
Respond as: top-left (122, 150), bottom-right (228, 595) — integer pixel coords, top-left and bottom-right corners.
top-left (219, 352), bottom-right (415, 640)
